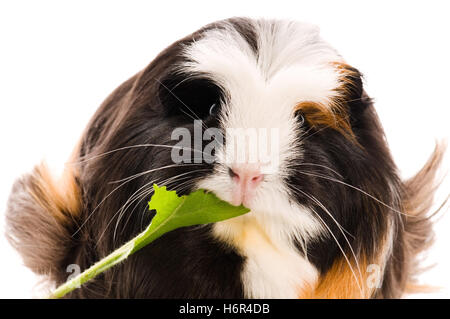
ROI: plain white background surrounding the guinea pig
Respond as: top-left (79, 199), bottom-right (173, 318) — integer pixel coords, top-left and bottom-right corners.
top-left (0, 0), bottom-right (450, 298)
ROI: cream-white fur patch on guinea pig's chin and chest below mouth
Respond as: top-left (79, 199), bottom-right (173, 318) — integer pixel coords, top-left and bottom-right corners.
top-left (214, 213), bottom-right (318, 298)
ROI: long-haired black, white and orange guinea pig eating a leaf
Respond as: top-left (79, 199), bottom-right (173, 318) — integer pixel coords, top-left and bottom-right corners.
top-left (6, 18), bottom-right (443, 298)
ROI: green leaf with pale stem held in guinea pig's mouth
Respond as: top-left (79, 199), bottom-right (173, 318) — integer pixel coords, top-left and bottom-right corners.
top-left (50, 184), bottom-right (249, 298)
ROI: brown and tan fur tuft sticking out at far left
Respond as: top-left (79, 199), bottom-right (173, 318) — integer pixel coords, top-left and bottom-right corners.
top-left (6, 164), bottom-right (80, 282)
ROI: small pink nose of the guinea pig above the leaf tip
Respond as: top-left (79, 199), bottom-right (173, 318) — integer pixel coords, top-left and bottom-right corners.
top-left (228, 164), bottom-right (264, 205)
